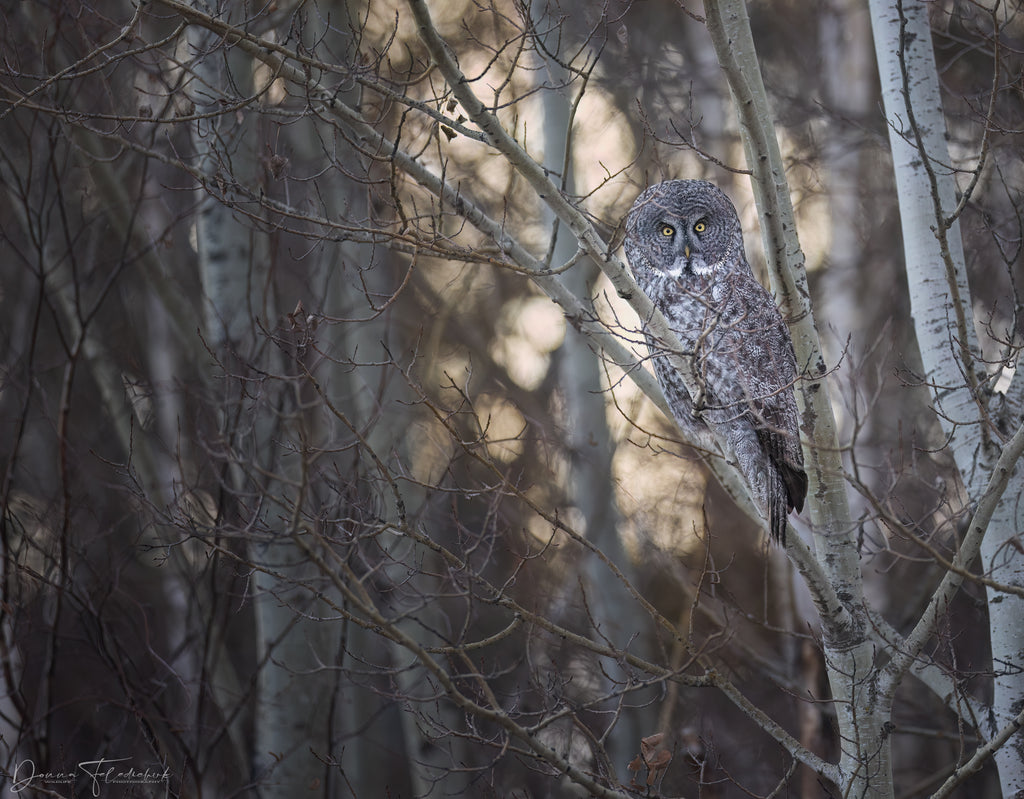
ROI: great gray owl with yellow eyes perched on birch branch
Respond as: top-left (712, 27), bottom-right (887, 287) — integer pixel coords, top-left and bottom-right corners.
top-left (625, 180), bottom-right (807, 543)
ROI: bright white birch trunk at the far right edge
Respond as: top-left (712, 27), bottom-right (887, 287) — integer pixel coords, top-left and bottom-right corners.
top-left (870, 0), bottom-right (1024, 797)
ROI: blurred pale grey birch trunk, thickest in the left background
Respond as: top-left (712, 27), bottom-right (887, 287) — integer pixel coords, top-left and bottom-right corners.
top-left (187, 17), bottom-right (338, 799)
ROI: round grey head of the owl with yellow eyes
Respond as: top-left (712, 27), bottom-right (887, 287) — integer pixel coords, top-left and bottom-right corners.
top-left (625, 180), bottom-right (745, 285)
